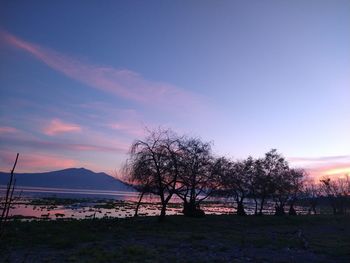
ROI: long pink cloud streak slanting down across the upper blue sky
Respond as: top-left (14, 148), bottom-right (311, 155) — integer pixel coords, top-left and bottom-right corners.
top-left (0, 31), bottom-right (202, 109)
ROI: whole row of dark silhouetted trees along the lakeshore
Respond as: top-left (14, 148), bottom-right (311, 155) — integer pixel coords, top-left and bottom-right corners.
top-left (124, 129), bottom-right (350, 220)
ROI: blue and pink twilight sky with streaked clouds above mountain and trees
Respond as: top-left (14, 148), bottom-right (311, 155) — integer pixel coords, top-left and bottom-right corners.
top-left (0, 0), bottom-right (350, 177)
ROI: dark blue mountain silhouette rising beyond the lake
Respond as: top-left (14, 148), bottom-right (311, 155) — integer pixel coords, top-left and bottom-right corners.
top-left (0, 168), bottom-right (135, 191)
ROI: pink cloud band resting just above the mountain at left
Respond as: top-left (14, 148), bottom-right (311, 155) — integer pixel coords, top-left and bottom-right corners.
top-left (0, 151), bottom-right (79, 172)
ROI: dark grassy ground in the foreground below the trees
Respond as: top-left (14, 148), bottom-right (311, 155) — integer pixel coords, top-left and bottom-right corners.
top-left (0, 215), bottom-right (350, 262)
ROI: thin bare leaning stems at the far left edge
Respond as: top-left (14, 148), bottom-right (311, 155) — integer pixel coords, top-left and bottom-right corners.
top-left (0, 153), bottom-right (19, 238)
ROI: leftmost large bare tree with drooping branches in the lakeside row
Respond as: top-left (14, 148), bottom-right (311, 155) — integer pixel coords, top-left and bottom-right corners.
top-left (125, 129), bottom-right (180, 220)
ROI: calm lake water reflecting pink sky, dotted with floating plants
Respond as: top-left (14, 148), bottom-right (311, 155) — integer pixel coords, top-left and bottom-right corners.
top-left (0, 187), bottom-right (307, 220)
